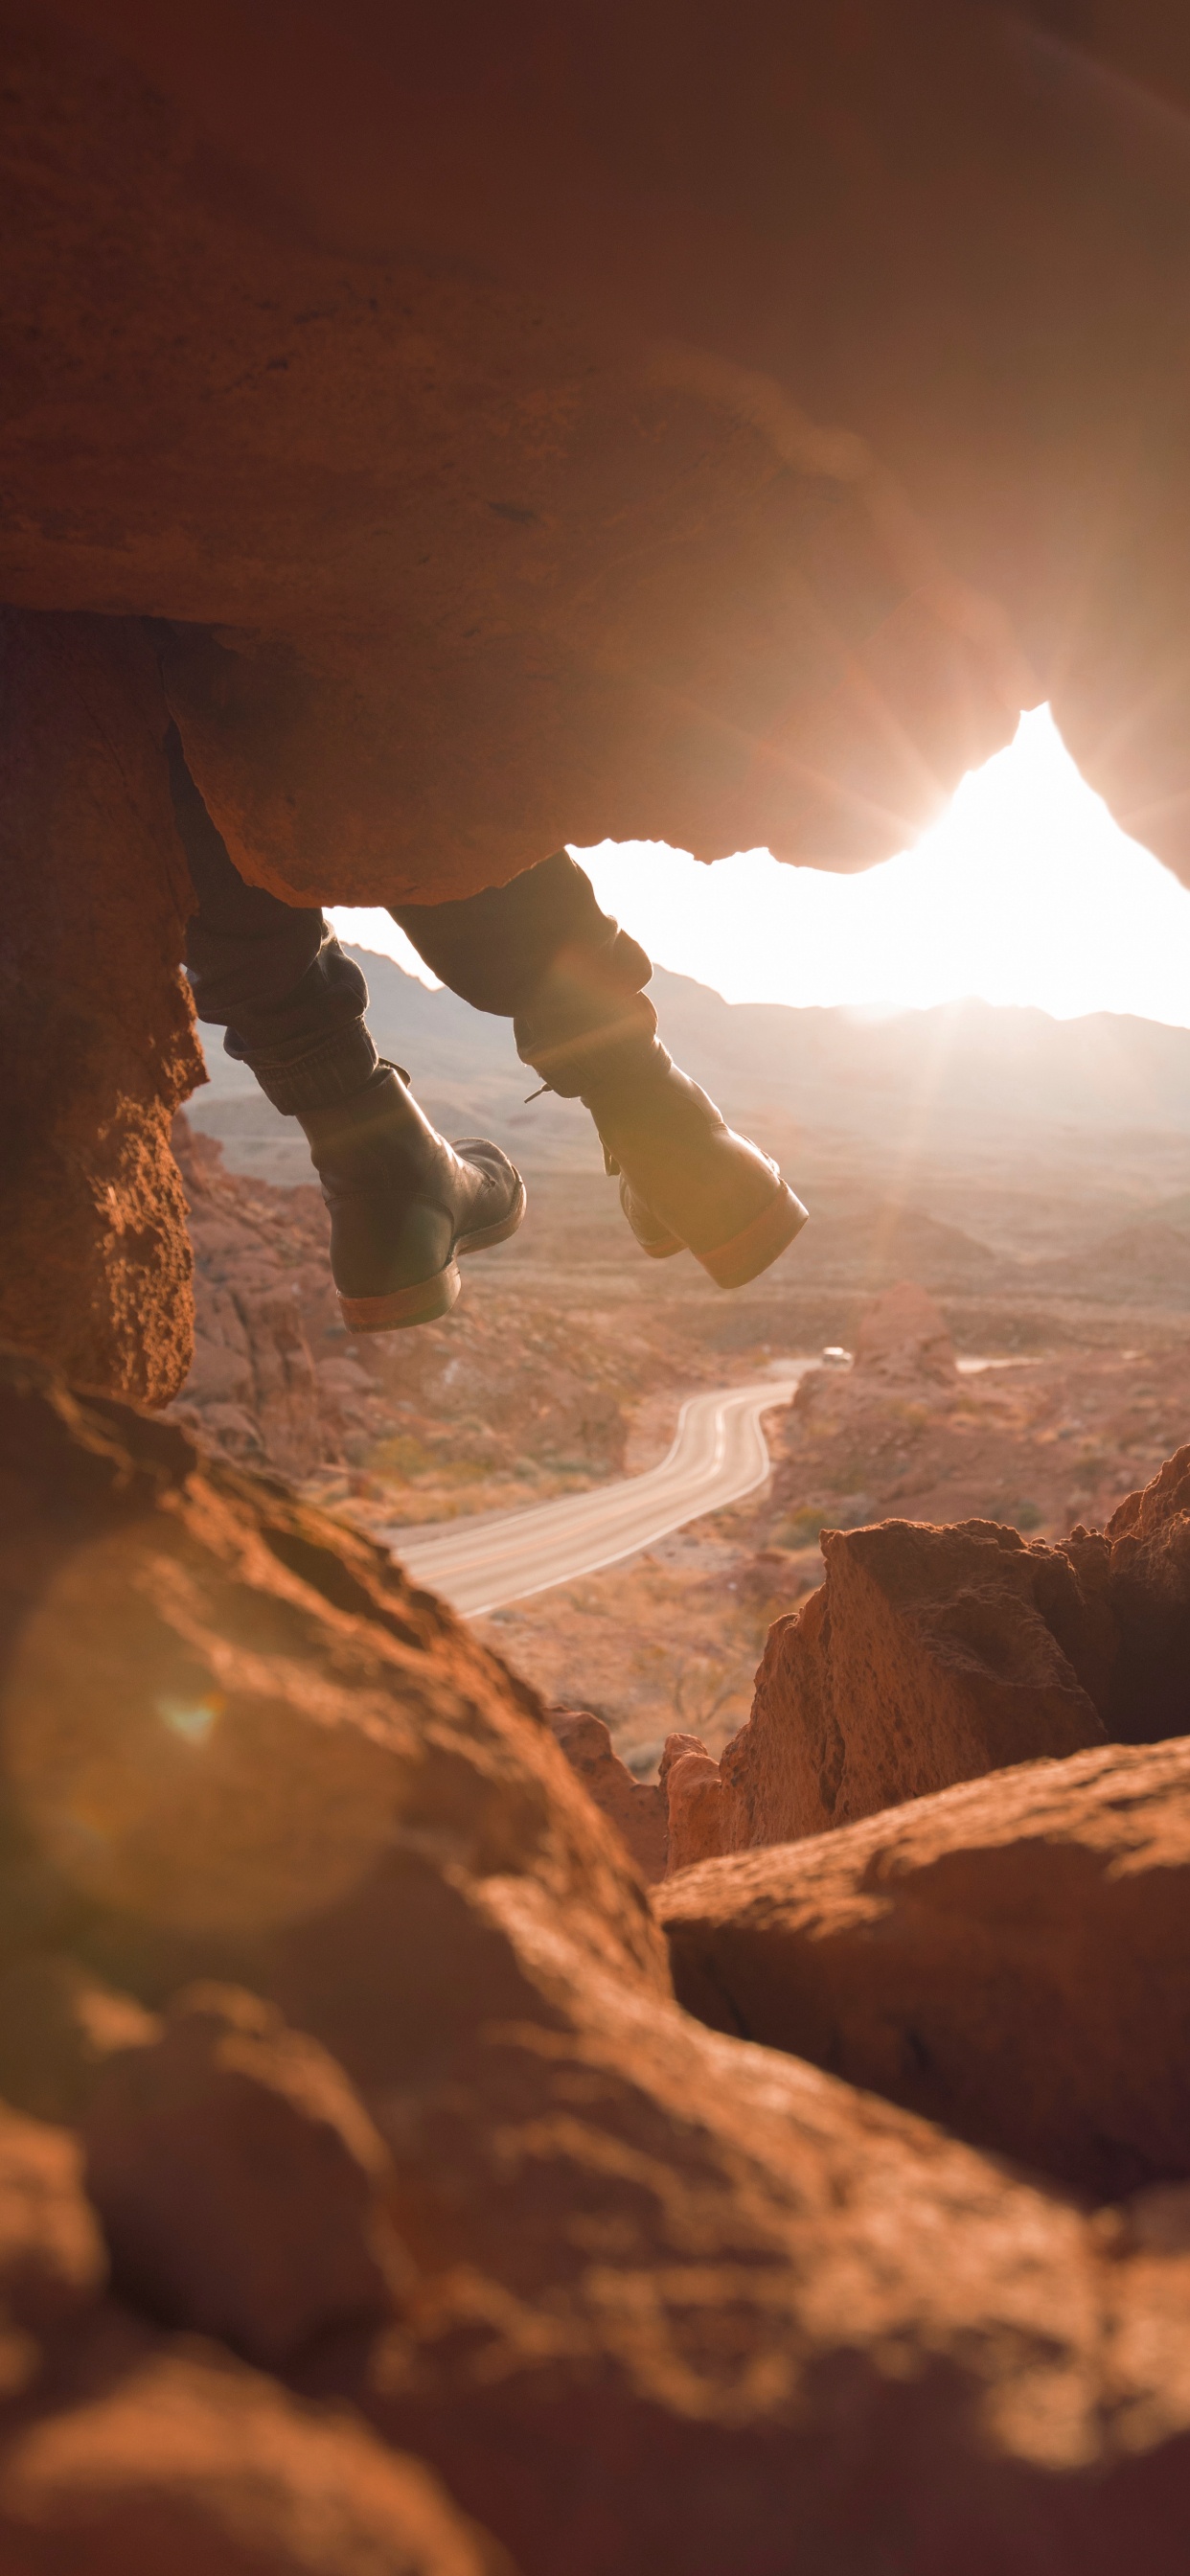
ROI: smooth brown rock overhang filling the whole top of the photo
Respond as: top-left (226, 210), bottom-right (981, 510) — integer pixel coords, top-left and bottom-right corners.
top-left (0, 0), bottom-right (1190, 902)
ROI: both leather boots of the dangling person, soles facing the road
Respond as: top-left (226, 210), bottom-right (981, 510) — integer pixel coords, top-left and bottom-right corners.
top-left (299, 1012), bottom-right (806, 1332)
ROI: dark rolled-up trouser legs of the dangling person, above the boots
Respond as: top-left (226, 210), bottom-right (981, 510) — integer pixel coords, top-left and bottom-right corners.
top-left (168, 726), bottom-right (657, 1116)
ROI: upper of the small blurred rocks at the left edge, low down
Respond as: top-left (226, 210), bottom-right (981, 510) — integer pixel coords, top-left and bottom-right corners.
top-left (0, 1953), bottom-right (160, 2126)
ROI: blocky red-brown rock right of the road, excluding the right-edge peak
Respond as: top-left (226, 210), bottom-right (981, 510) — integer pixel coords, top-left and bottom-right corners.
top-left (721, 1520), bottom-right (1115, 1852)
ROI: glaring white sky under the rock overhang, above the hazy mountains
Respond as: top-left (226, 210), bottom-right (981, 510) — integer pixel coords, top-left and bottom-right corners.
top-left (332, 706), bottom-right (1190, 1028)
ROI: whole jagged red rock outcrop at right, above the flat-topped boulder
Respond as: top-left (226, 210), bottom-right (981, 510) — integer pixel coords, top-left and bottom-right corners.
top-left (690, 1432), bottom-right (1190, 1868)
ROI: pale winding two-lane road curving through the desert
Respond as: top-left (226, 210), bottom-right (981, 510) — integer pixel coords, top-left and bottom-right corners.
top-left (386, 1360), bottom-right (814, 1618)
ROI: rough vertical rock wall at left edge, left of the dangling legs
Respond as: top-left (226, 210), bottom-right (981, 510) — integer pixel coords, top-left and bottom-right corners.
top-left (0, 613), bottom-right (203, 1404)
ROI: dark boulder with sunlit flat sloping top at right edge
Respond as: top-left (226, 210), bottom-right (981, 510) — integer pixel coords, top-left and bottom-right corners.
top-left (659, 1741), bottom-right (1190, 2200)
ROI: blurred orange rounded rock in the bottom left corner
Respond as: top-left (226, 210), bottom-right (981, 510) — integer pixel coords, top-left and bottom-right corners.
top-left (0, 2339), bottom-right (513, 2576)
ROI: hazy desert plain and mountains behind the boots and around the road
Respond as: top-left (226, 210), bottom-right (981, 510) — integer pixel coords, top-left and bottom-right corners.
top-left (177, 954), bottom-right (1190, 1780)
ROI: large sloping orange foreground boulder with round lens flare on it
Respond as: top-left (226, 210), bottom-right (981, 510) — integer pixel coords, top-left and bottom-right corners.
top-left (0, 1363), bottom-right (1190, 2576)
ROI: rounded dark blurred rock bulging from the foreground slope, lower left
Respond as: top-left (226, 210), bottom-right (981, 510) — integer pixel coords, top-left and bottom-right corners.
top-left (85, 1986), bottom-right (409, 2365)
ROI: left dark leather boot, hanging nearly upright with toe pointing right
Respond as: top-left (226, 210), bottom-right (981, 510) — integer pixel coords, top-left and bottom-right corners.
top-left (299, 1064), bottom-right (525, 1332)
